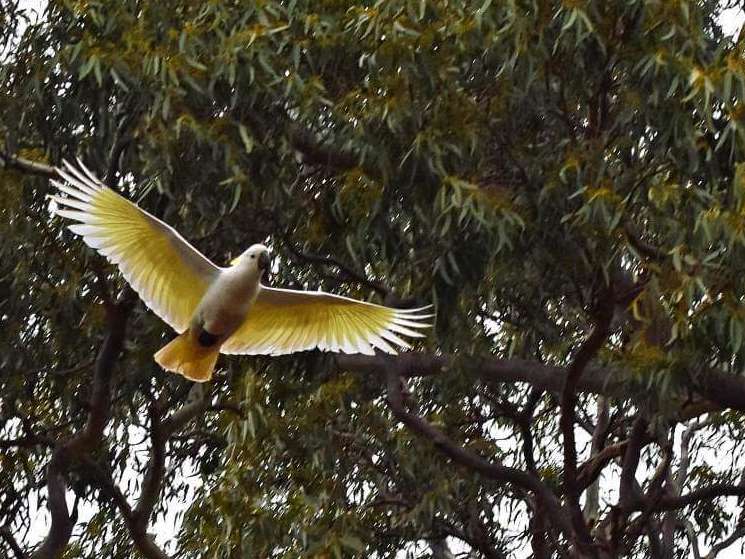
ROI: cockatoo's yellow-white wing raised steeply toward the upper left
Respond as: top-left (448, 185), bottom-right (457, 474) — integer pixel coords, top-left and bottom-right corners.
top-left (51, 161), bottom-right (220, 333)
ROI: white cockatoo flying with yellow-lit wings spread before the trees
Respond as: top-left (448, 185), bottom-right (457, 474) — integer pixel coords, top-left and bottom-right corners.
top-left (51, 161), bottom-right (433, 382)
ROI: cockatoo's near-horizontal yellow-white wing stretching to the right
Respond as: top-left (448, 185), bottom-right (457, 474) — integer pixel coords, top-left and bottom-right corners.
top-left (220, 285), bottom-right (434, 355)
